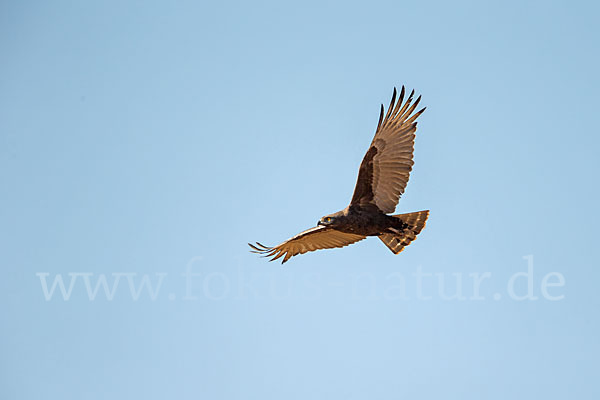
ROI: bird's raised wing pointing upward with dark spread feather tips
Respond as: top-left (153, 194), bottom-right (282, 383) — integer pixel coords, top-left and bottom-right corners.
top-left (350, 86), bottom-right (425, 214)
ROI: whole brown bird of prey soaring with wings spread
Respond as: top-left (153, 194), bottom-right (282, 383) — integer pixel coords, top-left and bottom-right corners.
top-left (248, 86), bottom-right (429, 263)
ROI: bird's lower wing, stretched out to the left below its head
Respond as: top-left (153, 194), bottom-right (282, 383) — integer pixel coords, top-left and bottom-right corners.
top-left (248, 225), bottom-right (365, 264)
